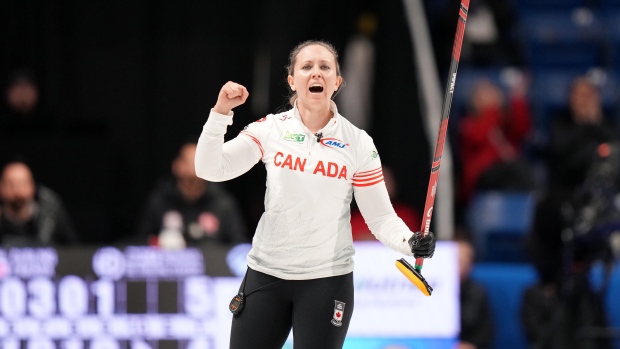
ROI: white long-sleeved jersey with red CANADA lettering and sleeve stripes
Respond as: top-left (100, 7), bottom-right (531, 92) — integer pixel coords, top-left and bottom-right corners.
top-left (196, 103), bottom-right (412, 280)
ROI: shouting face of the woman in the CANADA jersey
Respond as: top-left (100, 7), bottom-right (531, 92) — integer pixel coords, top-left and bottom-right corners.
top-left (287, 45), bottom-right (342, 107)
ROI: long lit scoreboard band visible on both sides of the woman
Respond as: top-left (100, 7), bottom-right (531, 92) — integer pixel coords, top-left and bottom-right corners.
top-left (0, 243), bottom-right (458, 349)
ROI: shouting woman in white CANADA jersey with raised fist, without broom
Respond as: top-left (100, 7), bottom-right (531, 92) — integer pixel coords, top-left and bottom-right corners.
top-left (196, 41), bottom-right (435, 348)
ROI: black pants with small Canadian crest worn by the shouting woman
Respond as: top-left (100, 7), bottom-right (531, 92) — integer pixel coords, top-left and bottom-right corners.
top-left (230, 269), bottom-right (353, 349)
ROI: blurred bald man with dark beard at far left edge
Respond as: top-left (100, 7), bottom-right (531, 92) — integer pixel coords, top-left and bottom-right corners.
top-left (0, 161), bottom-right (78, 246)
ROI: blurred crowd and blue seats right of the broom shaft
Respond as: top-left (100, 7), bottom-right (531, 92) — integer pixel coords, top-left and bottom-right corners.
top-left (428, 0), bottom-right (620, 348)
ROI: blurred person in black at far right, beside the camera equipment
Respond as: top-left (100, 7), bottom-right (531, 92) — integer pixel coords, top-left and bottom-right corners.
top-left (528, 77), bottom-right (620, 282)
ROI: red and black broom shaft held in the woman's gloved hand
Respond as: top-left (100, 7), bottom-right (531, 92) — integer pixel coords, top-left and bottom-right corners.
top-left (414, 0), bottom-right (469, 271)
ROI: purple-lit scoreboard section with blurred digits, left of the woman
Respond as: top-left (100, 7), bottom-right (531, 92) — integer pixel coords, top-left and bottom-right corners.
top-left (0, 246), bottom-right (238, 349)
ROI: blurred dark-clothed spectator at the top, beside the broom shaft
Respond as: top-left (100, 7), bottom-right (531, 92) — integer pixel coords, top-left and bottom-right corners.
top-left (431, 0), bottom-right (524, 75)
